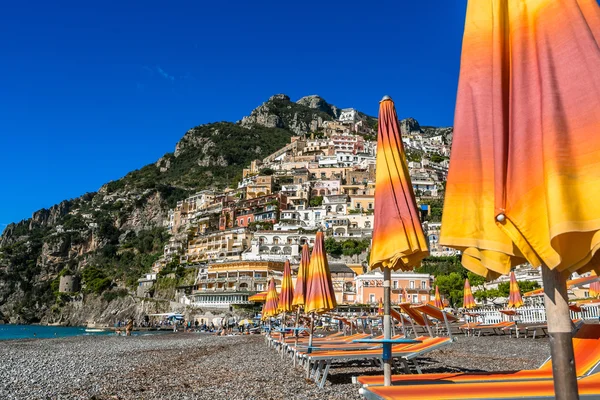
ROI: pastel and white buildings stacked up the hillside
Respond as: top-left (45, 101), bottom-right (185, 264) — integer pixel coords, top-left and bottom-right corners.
top-left (149, 109), bottom-right (449, 308)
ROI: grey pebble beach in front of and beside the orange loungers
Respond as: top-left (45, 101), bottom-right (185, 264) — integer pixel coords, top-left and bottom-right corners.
top-left (0, 333), bottom-right (550, 400)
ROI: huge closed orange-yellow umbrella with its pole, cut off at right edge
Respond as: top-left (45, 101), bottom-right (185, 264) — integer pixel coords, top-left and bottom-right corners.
top-left (439, 0), bottom-right (600, 399)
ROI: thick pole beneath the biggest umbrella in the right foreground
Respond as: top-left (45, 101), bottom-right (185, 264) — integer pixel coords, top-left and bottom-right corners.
top-left (542, 265), bottom-right (579, 400)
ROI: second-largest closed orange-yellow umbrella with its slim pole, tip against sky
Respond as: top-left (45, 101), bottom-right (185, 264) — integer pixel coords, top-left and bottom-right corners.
top-left (370, 96), bottom-right (429, 386)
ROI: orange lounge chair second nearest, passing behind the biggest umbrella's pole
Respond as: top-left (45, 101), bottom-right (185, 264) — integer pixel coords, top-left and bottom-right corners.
top-left (357, 325), bottom-right (600, 386)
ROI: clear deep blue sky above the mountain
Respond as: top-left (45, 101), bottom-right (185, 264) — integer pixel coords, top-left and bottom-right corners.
top-left (0, 0), bottom-right (466, 227)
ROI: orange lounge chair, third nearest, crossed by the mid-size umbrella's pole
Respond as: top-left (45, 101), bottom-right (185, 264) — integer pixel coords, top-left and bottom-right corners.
top-left (301, 337), bottom-right (452, 388)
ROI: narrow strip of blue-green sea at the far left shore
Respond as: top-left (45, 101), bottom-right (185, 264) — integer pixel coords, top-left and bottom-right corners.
top-left (0, 325), bottom-right (158, 340)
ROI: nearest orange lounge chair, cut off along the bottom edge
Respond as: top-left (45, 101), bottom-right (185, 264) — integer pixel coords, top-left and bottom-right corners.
top-left (360, 373), bottom-right (600, 400)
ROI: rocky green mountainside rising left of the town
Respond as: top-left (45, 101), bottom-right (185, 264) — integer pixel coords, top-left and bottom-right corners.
top-left (0, 94), bottom-right (450, 324)
